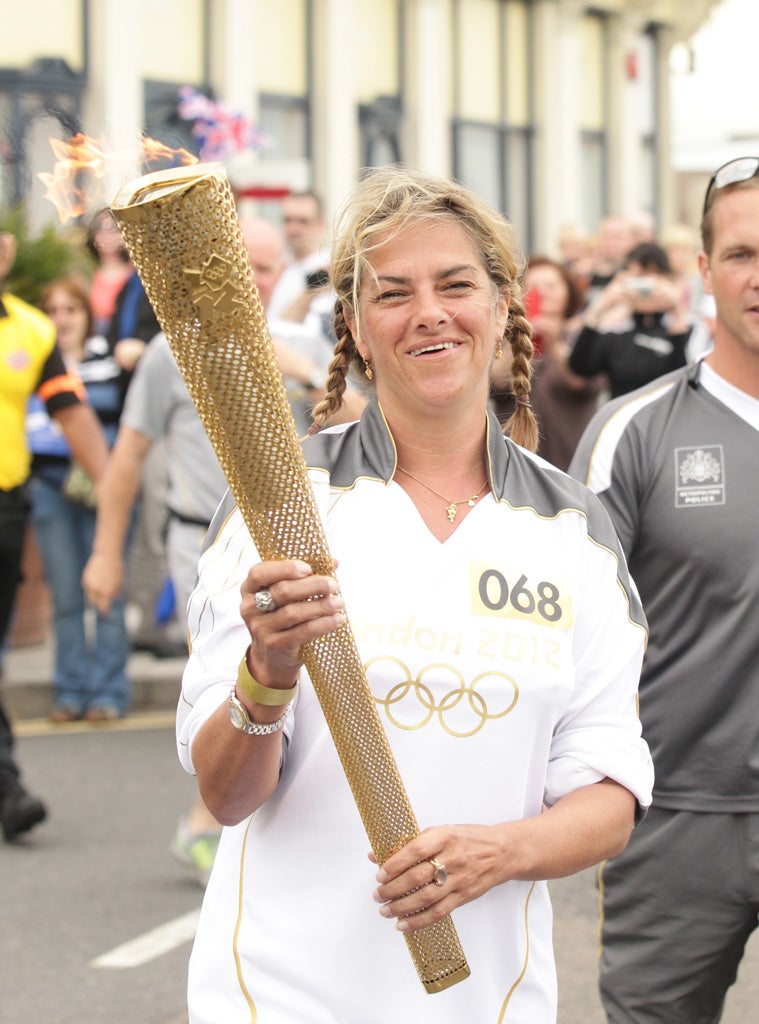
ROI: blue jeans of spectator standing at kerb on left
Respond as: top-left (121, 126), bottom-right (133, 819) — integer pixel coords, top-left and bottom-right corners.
top-left (31, 477), bottom-right (131, 714)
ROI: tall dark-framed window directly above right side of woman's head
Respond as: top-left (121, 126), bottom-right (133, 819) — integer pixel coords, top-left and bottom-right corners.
top-left (453, 0), bottom-right (534, 251)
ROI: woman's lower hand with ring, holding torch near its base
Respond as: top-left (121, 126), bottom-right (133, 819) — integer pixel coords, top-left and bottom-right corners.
top-left (370, 825), bottom-right (511, 932)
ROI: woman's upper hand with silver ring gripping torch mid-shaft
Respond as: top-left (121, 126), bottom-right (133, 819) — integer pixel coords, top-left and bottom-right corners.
top-left (240, 560), bottom-right (347, 689)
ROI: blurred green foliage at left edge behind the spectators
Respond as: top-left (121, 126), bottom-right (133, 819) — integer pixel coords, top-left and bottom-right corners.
top-left (0, 207), bottom-right (93, 306)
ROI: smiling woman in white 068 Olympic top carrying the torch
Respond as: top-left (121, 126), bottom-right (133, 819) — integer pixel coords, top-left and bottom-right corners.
top-left (177, 168), bottom-right (652, 1024)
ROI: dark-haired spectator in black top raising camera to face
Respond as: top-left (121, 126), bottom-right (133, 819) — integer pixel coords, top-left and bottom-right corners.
top-left (568, 242), bottom-right (692, 398)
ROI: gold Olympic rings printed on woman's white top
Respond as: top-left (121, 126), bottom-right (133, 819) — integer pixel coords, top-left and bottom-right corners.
top-left (366, 655), bottom-right (519, 739)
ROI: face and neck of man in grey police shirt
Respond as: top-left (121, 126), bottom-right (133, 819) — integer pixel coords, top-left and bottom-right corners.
top-left (699, 187), bottom-right (759, 391)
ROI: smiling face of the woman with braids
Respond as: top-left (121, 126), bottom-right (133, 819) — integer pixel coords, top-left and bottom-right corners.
top-left (346, 218), bottom-right (508, 417)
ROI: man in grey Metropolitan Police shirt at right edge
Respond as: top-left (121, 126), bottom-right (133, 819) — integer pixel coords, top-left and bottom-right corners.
top-left (570, 158), bottom-right (759, 1024)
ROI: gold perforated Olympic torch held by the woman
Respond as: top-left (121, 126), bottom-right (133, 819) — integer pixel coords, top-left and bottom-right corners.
top-left (112, 164), bottom-right (469, 992)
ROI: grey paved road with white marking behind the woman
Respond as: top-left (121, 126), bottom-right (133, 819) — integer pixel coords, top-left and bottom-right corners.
top-left (5, 713), bottom-right (759, 1024)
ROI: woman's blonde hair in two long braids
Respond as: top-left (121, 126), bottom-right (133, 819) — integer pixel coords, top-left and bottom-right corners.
top-left (313, 167), bottom-right (538, 452)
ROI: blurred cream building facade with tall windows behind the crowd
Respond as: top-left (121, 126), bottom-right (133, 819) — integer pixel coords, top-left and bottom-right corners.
top-left (0, 0), bottom-right (718, 251)
